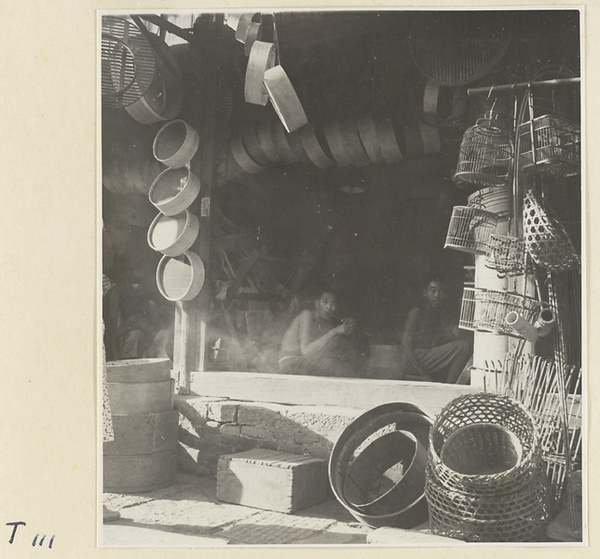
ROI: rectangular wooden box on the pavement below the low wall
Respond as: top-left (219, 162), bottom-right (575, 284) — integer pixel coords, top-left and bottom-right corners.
top-left (217, 449), bottom-right (329, 513)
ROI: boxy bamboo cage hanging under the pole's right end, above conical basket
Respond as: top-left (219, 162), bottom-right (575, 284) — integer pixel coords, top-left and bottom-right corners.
top-left (518, 114), bottom-right (581, 177)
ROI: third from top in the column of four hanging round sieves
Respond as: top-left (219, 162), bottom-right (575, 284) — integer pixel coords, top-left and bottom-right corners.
top-left (148, 210), bottom-right (200, 256)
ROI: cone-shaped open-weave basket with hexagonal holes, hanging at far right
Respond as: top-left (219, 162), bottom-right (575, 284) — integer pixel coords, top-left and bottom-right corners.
top-left (523, 190), bottom-right (580, 272)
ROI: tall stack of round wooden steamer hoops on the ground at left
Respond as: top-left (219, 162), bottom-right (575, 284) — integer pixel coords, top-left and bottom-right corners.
top-left (102, 359), bottom-right (179, 493)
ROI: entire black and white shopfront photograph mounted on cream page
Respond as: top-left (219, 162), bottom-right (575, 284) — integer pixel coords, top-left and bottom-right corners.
top-left (99, 6), bottom-right (594, 552)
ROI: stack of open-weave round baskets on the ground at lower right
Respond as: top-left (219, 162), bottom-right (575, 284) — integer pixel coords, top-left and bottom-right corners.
top-left (425, 394), bottom-right (548, 542)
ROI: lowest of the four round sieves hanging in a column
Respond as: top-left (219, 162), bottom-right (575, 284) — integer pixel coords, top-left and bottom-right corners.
top-left (156, 251), bottom-right (205, 301)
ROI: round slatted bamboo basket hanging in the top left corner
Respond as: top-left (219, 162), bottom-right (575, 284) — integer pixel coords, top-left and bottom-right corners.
top-left (101, 16), bottom-right (157, 108)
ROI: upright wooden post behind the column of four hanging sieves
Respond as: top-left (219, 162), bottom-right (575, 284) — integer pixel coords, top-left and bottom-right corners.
top-left (173, 14), bottom-right (223, 394)
